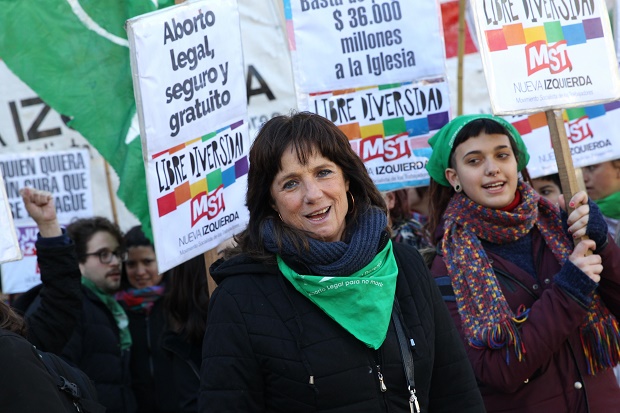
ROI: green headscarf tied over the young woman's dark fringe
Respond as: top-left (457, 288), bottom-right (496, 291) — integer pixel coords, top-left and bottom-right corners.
top-left (426, 115), bottom-right (530, 186)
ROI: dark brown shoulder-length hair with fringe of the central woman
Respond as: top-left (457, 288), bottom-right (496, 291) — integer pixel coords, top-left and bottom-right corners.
top-left (226, 112), bottom-right (387, 260)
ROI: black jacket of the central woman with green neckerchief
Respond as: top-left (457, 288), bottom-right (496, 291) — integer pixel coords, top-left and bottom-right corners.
top-left (199, 244), bottom-right (484, 413)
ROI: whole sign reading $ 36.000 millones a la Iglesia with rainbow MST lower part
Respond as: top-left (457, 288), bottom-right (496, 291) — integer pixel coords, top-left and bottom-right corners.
top-left (284, 0), bottom-right (450, 191)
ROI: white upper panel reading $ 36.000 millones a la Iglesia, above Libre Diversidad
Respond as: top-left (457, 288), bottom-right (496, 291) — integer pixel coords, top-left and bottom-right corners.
top-left (284, 0), bottom-right (445, 93)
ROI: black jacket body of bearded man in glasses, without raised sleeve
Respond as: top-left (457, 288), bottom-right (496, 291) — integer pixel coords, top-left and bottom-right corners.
top-left (61, 287), bottom-right (136, 413)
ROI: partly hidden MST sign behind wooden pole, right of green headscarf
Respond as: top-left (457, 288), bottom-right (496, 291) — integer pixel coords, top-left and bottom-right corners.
top-left (506, 102), bottom-right (620, 178)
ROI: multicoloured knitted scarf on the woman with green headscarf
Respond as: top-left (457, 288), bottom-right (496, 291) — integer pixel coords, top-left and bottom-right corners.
top-left (442, 182), bottom-right (620, 374)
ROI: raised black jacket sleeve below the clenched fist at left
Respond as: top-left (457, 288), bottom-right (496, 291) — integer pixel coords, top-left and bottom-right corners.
top-left (13, 237), bottom-right (82, 354)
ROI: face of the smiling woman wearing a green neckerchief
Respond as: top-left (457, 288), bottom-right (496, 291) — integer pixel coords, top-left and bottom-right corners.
top-left (271, 147), bottom-right (349, 242)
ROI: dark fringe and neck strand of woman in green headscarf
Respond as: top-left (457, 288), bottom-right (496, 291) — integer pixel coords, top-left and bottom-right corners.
top-left (428, 118), bottom-right (522, 241)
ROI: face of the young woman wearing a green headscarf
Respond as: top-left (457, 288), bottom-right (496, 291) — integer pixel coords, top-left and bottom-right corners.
top-left (446, 132), bottom-right (518, 209)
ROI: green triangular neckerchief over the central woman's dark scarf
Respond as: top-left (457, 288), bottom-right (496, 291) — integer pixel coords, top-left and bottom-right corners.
top-left (277, 241), bottom-right (398, 350)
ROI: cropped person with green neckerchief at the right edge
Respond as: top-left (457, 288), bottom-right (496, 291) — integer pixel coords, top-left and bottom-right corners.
top-left (581, 159), bottom-right (620, 238)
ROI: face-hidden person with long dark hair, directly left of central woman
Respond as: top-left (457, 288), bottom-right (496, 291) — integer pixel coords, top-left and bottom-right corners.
top-left (162, 254), bottom-right (209, 413)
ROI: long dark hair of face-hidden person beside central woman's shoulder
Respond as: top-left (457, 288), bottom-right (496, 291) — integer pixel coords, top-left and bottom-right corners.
top-left (164, 254), bottom-right (209, 345)
